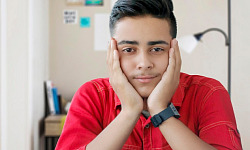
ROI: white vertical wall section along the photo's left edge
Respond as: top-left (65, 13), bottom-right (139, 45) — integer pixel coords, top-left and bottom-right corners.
top-left (0, 0), bottom-right (49, 150)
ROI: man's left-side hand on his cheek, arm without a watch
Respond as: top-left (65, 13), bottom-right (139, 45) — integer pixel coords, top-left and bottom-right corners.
top-left (107, 39), bottom-right (143, 115)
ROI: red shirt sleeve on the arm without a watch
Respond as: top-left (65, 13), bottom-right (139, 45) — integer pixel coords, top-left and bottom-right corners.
top-left (56, 82), bottom-right (103, 150)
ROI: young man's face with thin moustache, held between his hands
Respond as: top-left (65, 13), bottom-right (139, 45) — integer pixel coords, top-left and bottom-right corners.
top-left (113, 16), bottom-right (172, 97)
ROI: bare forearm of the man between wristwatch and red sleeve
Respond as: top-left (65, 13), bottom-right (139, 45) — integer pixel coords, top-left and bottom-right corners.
top-left (159, 117), bottom-right (215, 150)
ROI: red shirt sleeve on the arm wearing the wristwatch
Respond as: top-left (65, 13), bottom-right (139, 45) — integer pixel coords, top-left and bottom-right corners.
top-left (198, 87), bottom-right (242, 150)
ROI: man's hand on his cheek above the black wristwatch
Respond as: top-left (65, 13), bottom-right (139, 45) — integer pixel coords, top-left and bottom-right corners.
top-left (147, 39), bottom-right (181, 116)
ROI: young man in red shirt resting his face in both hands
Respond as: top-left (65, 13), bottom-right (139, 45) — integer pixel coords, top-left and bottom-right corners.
top-left (56, 0), bottom-right (242, 150)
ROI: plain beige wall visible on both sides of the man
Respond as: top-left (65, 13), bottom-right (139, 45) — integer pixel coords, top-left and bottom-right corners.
top-left (50, 0), bottom-right (250, 149)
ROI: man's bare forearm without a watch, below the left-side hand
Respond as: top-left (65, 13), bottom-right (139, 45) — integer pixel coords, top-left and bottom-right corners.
top-left (86, 111), bottom-right (140, 150)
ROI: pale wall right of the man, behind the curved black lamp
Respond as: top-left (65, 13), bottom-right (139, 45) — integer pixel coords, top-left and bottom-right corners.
top-left (173, 0), bottom-right (250, 149)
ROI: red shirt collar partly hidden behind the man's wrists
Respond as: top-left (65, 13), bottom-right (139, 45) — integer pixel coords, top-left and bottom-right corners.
top-left (114, 73), bottom-right (185, 109)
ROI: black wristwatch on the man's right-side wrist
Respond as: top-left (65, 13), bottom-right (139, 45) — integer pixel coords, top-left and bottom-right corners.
top-left (151, 103), bottom-right (180, 127)
